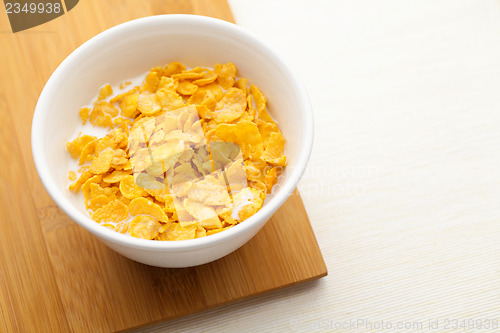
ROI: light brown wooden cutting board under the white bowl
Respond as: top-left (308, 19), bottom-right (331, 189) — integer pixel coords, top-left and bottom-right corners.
top-left (0, 0), bottom-right (327, 332)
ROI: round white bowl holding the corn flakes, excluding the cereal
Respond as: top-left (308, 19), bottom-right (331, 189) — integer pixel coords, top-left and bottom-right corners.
top-left (31, 15), bottom-right (313, 267)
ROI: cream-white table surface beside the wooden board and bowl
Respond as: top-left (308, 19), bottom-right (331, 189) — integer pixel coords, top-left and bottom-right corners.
top-left (146, 0), bottom-right (500, 332)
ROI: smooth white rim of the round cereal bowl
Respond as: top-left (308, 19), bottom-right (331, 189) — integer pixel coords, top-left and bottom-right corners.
top-left (31, 14), bottom-right (314, 251)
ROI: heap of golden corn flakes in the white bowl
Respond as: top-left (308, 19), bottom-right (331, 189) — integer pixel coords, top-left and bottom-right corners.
top-left (66, 62), bottom-right (286, 241)
